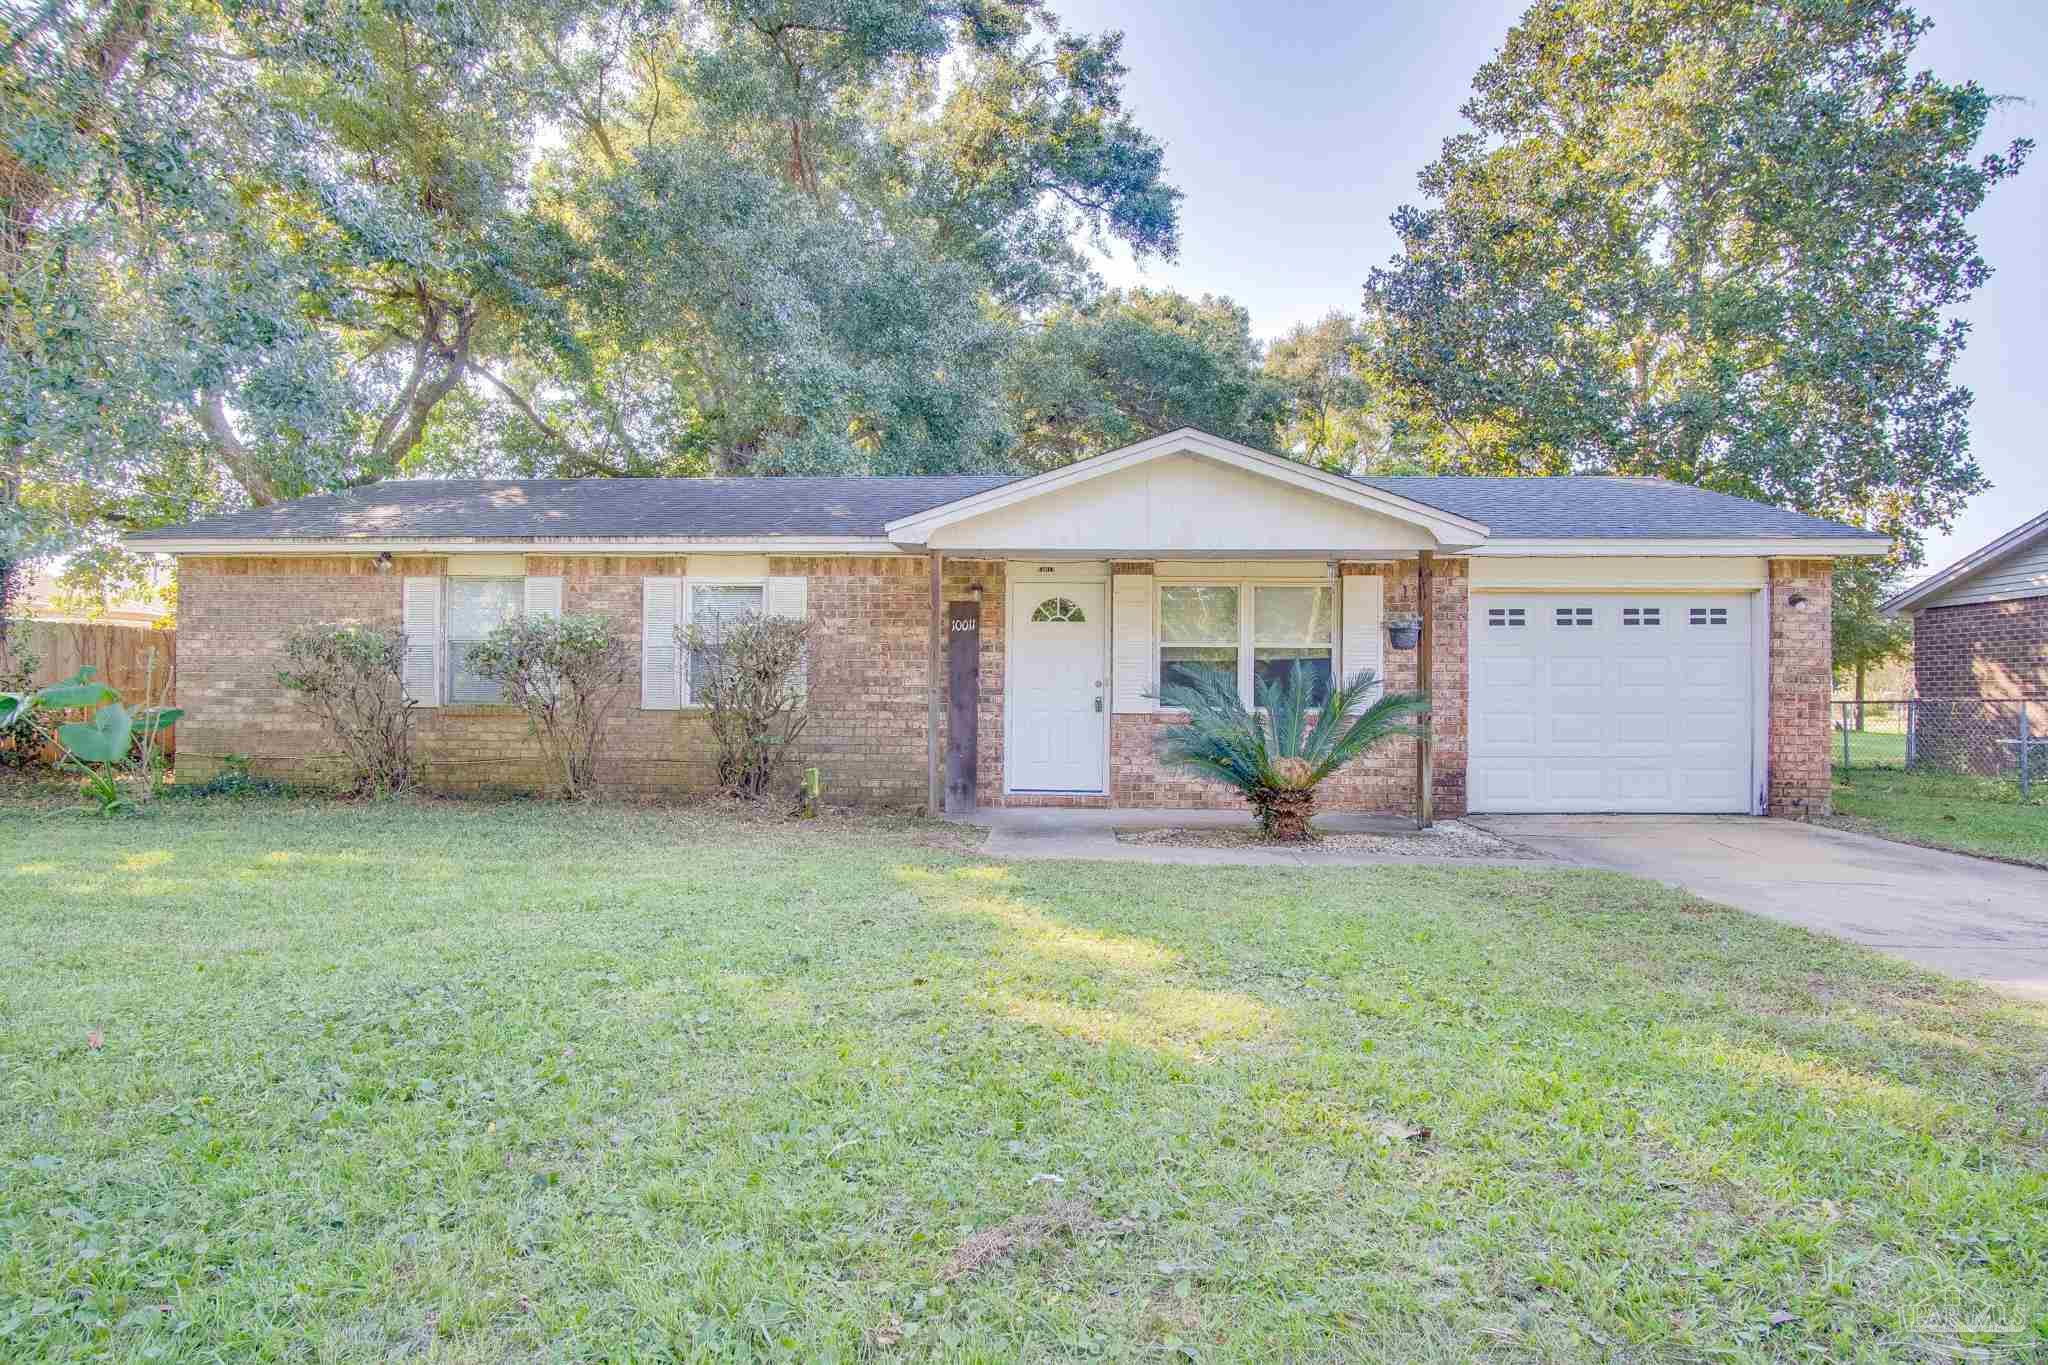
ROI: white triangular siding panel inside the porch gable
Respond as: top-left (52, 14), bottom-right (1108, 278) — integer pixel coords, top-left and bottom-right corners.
top-left (929, 454), bottom-right (1436, 548)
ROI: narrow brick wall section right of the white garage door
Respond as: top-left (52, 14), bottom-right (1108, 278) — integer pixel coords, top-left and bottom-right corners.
top-left (1765, 559), bottom-right (1835, 819)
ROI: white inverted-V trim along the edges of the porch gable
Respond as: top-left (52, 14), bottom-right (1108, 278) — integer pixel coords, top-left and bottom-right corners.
top-left (883, 426), bottom-right (1487, 546)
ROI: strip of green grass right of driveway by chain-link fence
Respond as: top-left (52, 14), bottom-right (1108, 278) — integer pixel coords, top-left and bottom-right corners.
top-left (1835, 765), bottom-right (2048, 868)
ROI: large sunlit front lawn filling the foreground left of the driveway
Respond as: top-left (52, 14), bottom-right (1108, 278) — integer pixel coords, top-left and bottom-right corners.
top-left (0, 800), bottom-right (2048, 1361)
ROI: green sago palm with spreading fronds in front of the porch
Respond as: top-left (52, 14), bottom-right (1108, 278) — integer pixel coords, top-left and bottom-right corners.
top-left (1159, 669), bottom-right (1430, 843)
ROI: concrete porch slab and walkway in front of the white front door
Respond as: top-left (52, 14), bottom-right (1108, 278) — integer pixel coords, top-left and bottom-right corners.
top-left (965, 808), bottom-right (1556, 868)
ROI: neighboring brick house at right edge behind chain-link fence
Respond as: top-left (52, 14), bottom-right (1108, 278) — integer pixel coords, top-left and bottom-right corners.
top-left (1884, 512), bottom-right (2048, 772)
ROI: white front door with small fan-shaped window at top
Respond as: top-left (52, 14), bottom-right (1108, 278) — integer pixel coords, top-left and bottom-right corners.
top-left (1004, 583), bottom-right (1110, 792)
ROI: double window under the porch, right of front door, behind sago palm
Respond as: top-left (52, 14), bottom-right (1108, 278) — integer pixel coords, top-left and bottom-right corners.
top-left (1159, 583), bottom-right (1337, 706)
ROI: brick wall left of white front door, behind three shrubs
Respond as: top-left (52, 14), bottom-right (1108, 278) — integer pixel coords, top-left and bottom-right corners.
top-left (178, 555), bottom-right (1001, 806)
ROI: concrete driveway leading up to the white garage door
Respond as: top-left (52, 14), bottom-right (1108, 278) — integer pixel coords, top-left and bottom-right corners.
top-left (1466, 814), bottom-right (2048, 999)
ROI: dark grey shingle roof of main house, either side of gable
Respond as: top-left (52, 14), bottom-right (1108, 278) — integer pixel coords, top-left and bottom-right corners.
top-left (129, 475), bottom-right (1880, 548)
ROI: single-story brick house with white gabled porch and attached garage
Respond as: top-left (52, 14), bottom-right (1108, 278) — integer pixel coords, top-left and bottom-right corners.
top-left (129, 430), bottom-right (1886, 817)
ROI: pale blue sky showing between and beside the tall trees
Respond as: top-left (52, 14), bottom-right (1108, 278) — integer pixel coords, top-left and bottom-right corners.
top-left (1051, 0), bottom-right (2048, 567)
